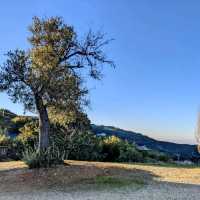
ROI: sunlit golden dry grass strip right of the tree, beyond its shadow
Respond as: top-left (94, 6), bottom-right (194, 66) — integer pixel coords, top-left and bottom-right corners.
top-left (64, 161), bottom-right (200, 185)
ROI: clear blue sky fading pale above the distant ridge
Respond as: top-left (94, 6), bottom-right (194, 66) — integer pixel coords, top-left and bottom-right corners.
top-left (0, 0), bottom-right (200, 143)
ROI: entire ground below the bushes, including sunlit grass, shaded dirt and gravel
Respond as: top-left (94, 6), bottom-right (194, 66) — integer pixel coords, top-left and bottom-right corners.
top-left (0, 161), bottom-right (200, 200)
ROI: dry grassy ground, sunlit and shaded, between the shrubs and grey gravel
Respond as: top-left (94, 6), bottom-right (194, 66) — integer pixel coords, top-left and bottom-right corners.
top-left (0, 161), bottom-right (200, 191)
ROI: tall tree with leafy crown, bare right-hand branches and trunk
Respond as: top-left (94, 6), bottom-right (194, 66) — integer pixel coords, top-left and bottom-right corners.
top-left (0, 17), bottom-right (114, 150)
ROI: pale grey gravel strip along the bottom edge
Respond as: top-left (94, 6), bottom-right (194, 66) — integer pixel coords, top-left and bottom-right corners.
top-left (0, 183), bottom-right (200, 200)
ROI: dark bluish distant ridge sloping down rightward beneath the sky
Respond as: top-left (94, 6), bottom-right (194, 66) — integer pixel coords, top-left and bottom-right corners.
top-left (92, 124), bottom-right (200, 160)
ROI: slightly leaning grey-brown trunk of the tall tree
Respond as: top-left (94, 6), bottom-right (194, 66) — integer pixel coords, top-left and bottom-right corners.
top-left (36, 96), bottom-right (50, 151)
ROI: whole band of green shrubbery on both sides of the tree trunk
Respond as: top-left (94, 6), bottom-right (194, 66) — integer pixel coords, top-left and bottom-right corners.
top-left (0, 112), bottom-right (170, 167)
